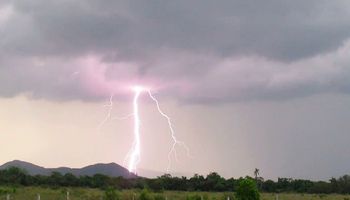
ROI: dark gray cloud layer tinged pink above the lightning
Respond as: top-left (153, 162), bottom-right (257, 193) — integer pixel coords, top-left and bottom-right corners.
top-left (0, 0), bottom-right (350, 102)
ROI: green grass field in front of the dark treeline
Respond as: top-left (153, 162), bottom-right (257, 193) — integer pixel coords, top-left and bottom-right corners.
top-left (0, 187), bottom-right (350, 200)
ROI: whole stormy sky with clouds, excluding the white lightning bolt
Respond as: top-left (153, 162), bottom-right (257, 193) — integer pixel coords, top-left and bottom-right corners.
top-left (0, 0), bottom-right (350, 180)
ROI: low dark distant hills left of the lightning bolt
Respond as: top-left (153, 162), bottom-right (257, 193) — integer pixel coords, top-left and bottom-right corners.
top-left (0, 160), bottom-right (137, 178)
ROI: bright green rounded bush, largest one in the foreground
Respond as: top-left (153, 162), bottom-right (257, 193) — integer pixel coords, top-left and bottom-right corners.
top-left (236, 178), bottom-right (260, 200)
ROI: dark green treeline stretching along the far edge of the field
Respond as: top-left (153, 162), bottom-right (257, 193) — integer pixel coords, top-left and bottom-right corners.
top-left (0, 167), bottom-right (350, 194)
